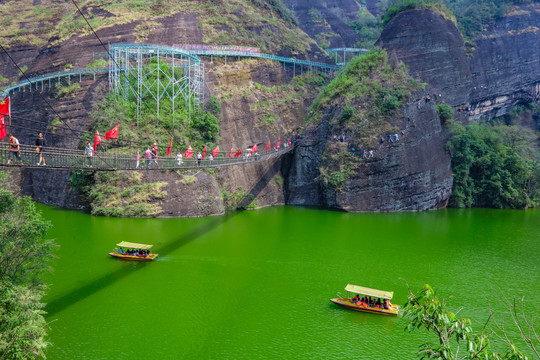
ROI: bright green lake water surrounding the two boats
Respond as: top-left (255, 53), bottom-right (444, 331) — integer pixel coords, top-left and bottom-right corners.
top-left (40, 206), bottom-right (540, 359)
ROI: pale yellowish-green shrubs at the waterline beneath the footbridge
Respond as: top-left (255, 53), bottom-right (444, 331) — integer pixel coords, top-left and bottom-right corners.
top-left (88, 171), bottom-right (167, 217)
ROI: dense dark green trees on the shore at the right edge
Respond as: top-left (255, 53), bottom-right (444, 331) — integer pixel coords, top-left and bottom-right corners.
top-left (447, 122), bottom-right (540, 209)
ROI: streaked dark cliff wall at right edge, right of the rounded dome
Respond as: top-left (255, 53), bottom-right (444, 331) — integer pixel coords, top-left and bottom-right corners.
top-left (470, 4), bottom-right (540, 118)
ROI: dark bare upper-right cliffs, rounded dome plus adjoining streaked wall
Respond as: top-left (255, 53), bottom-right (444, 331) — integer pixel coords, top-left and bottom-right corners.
top-left (377, 4), bottom-right (540, 119)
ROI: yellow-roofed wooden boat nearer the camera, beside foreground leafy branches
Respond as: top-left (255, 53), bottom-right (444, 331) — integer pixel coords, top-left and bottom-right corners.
top-left (330, 284), bottom-right (399, 316)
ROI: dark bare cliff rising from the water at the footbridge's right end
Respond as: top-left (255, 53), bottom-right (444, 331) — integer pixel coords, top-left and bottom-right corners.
top-left (287, 97), bottom-right (452, 211)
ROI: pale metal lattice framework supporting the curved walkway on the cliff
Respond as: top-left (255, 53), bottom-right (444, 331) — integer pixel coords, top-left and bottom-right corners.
top-left (109, 44), bottom-right (204, 121)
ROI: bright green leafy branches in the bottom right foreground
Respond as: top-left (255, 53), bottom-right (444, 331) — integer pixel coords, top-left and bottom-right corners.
top-left (402, 285), bottom-right (538, 360)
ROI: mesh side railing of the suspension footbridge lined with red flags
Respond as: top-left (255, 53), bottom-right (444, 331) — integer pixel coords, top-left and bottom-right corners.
top-left (0, 143), bottom-right (293, 170)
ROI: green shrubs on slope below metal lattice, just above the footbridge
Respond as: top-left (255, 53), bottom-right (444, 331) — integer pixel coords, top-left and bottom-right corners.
top-left (88, 59), bottom-right (220, 153)
